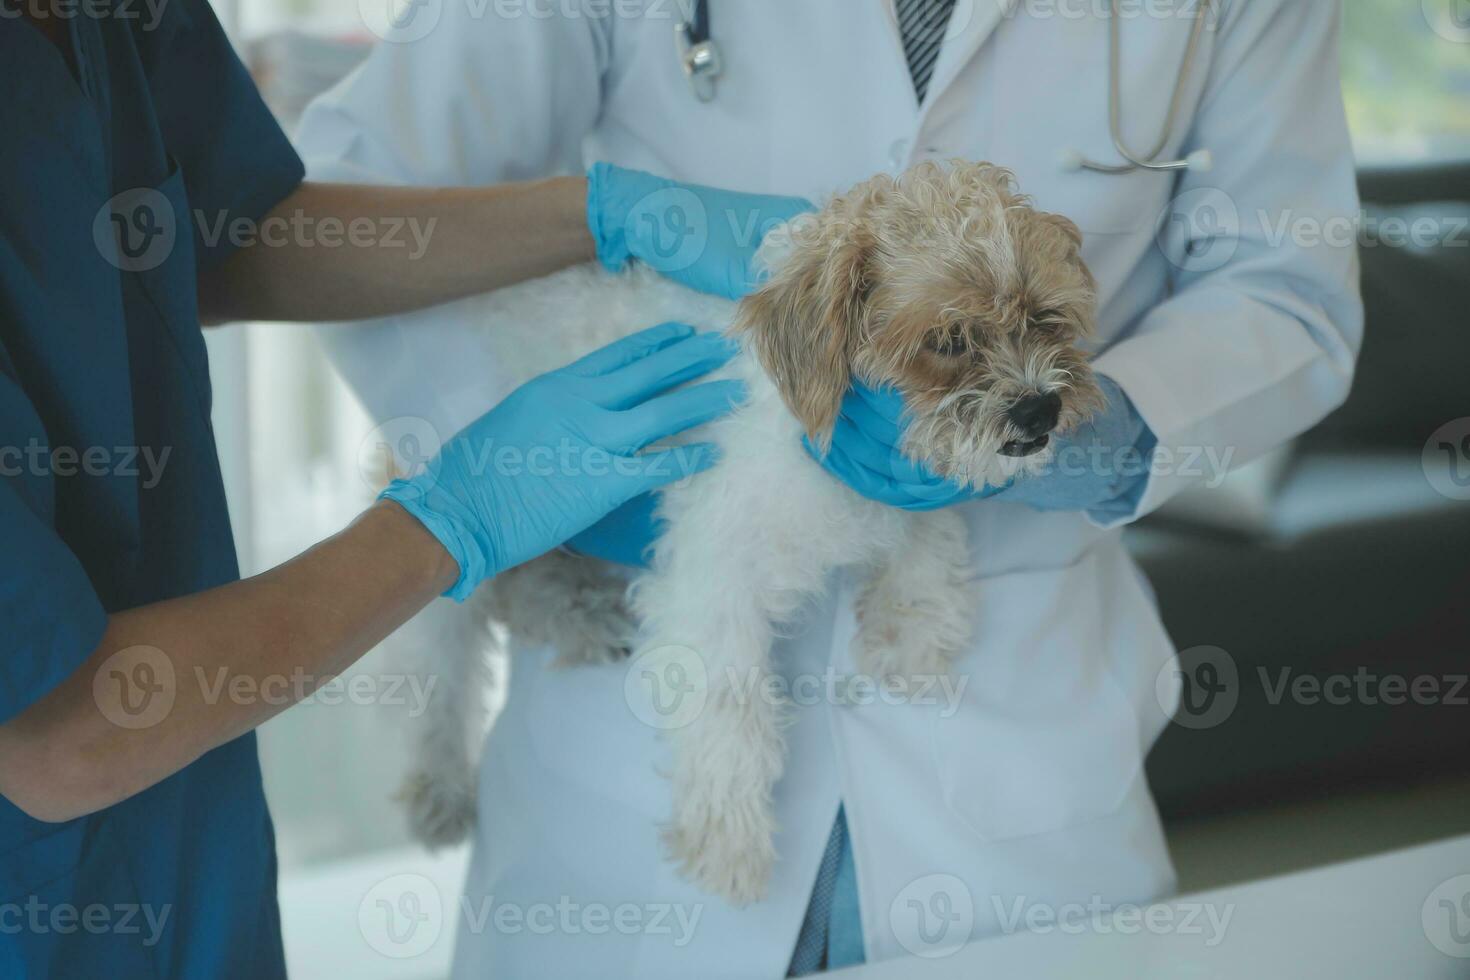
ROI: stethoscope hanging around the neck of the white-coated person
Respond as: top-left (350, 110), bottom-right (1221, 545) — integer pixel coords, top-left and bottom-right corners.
top-left (675, 0), bottom-right (1214, 175)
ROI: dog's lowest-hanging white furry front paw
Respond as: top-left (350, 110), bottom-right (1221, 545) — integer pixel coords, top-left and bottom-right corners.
top-left (663, 802), bottom-right (776, 907)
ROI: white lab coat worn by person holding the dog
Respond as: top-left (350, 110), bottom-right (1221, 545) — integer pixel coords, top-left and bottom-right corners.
top-left (300, 0), bottom-right (1361, 980)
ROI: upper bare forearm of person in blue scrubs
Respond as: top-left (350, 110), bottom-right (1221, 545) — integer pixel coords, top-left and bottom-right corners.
top-left (200, 178), bottom-right (595, 323)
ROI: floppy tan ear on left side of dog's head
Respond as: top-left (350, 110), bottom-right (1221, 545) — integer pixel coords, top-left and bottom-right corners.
top-left (735, 207), bottom-right (872, 451)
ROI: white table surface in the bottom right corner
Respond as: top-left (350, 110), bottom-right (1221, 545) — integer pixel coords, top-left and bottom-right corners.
top-left (832, 836), bottom-right (1470, 980)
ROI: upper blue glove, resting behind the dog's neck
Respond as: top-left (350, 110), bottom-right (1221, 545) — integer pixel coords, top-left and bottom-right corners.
top-left (587, 163), bottom-right (813, 300)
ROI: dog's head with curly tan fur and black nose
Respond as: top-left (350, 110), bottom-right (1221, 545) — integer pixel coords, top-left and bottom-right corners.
top-left (735, 162), bottom-right (1103, 483)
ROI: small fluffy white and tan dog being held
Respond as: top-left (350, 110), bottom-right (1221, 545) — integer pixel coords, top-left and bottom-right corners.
top-left (404, 162), bottom-right (1101, 904)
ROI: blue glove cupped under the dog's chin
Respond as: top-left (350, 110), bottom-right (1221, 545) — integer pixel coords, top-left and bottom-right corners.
top-left (807, 375), bottom-right (1155, 519)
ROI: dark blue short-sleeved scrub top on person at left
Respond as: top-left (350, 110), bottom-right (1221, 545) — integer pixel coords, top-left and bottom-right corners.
top-left (0, 0), bottom-right (303, 980)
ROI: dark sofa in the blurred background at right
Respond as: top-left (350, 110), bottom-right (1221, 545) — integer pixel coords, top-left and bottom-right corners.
top-left (1129, 165), bottom-right (1470, 820)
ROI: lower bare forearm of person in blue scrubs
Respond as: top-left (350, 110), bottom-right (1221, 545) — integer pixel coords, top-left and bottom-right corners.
top-left (0, 504), bottom-right (457, 820)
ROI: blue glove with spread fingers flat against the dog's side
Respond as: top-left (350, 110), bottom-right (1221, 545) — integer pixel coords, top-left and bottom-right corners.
top-left (381, 323), bottom-right (744, 601)
